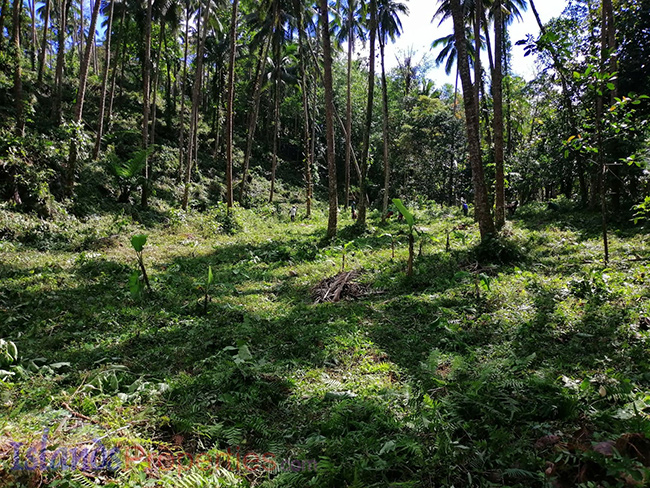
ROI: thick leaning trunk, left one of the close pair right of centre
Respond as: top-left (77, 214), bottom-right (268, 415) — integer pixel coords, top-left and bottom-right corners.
top-left (450, 0), bottom-right (495, 240)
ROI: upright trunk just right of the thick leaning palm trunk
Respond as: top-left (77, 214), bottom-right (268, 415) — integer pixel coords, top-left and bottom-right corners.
top-left (492, 0), bottom-right (506, 229)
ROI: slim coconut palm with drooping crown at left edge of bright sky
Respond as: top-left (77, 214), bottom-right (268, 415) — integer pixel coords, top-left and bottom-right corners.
top-left (377, 0), bottom-right (409, 220)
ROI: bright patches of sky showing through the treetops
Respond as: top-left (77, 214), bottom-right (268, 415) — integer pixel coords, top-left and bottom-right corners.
top-left (386, 0), bottom-right (568, 86)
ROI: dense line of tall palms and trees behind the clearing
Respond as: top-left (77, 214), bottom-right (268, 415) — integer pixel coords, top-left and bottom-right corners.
top-left (0, 0), bottom-right (650, 237)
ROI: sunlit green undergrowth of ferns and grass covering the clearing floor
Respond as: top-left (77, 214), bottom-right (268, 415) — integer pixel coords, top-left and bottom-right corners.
top-left (0, 200), bottom-right (650, 488)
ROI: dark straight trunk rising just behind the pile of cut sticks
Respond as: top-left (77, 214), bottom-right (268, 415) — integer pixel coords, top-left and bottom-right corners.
top-left (320, 0), bottom-right (338, 239)
